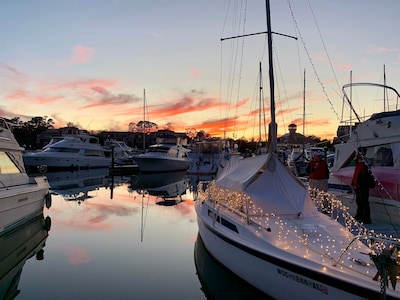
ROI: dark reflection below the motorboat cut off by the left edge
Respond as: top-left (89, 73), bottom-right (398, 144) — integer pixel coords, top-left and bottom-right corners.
top-left (0, 214), bottom-right (51, 299)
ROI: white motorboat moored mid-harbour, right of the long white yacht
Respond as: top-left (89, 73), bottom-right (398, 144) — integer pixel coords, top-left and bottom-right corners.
top-left (132, 144), bottom-right (190, 173)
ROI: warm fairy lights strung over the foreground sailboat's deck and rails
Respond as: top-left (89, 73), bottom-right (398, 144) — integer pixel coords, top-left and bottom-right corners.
top-left (199, 180), bottom-right (400, 274)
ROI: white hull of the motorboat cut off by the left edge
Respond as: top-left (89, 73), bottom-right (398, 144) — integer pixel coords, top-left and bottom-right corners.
top-left (0, 177), bottom-right (49, 232)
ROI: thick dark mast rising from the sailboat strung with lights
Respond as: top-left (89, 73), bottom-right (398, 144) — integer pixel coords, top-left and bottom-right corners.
top-left (265, 0), bottom-right (277, 152)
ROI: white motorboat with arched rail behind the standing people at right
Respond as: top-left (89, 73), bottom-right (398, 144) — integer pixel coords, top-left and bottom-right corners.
top-left (328, 83), bottom-right (400, 226)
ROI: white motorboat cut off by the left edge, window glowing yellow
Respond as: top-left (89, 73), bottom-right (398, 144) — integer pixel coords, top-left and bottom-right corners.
top-left (0, 118), bottom-right (51, 232)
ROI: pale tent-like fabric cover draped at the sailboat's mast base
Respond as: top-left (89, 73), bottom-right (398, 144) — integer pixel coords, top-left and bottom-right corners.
top-left (216, 154), bottom-right (318, 217)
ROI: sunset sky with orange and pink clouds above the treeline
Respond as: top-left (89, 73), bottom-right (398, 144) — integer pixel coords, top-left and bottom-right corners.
top-left (0, 0), bottom-right (400, 139)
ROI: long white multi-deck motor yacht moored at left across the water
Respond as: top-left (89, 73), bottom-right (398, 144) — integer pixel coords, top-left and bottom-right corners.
top-left (23, 133), bottom-right (111, 173)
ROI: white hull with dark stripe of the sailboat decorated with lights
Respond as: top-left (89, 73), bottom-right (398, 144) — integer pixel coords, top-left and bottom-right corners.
top-left (196, 202), bottom-right (398, 299)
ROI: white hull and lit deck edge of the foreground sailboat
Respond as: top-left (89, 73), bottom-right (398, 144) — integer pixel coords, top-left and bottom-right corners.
top-left (196, 202), bottom-right (400, 299)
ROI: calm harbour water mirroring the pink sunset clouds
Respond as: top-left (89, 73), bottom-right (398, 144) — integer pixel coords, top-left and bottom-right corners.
top-left (0, 170), bottom-right (268, 299)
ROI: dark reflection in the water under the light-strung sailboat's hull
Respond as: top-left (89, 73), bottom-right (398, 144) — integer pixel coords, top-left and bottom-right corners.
top-left (194, 235), bottom-right (273, 300)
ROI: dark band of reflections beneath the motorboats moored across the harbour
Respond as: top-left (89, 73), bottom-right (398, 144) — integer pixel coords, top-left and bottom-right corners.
top-left (40, 168), bottom-right (213, 205)
